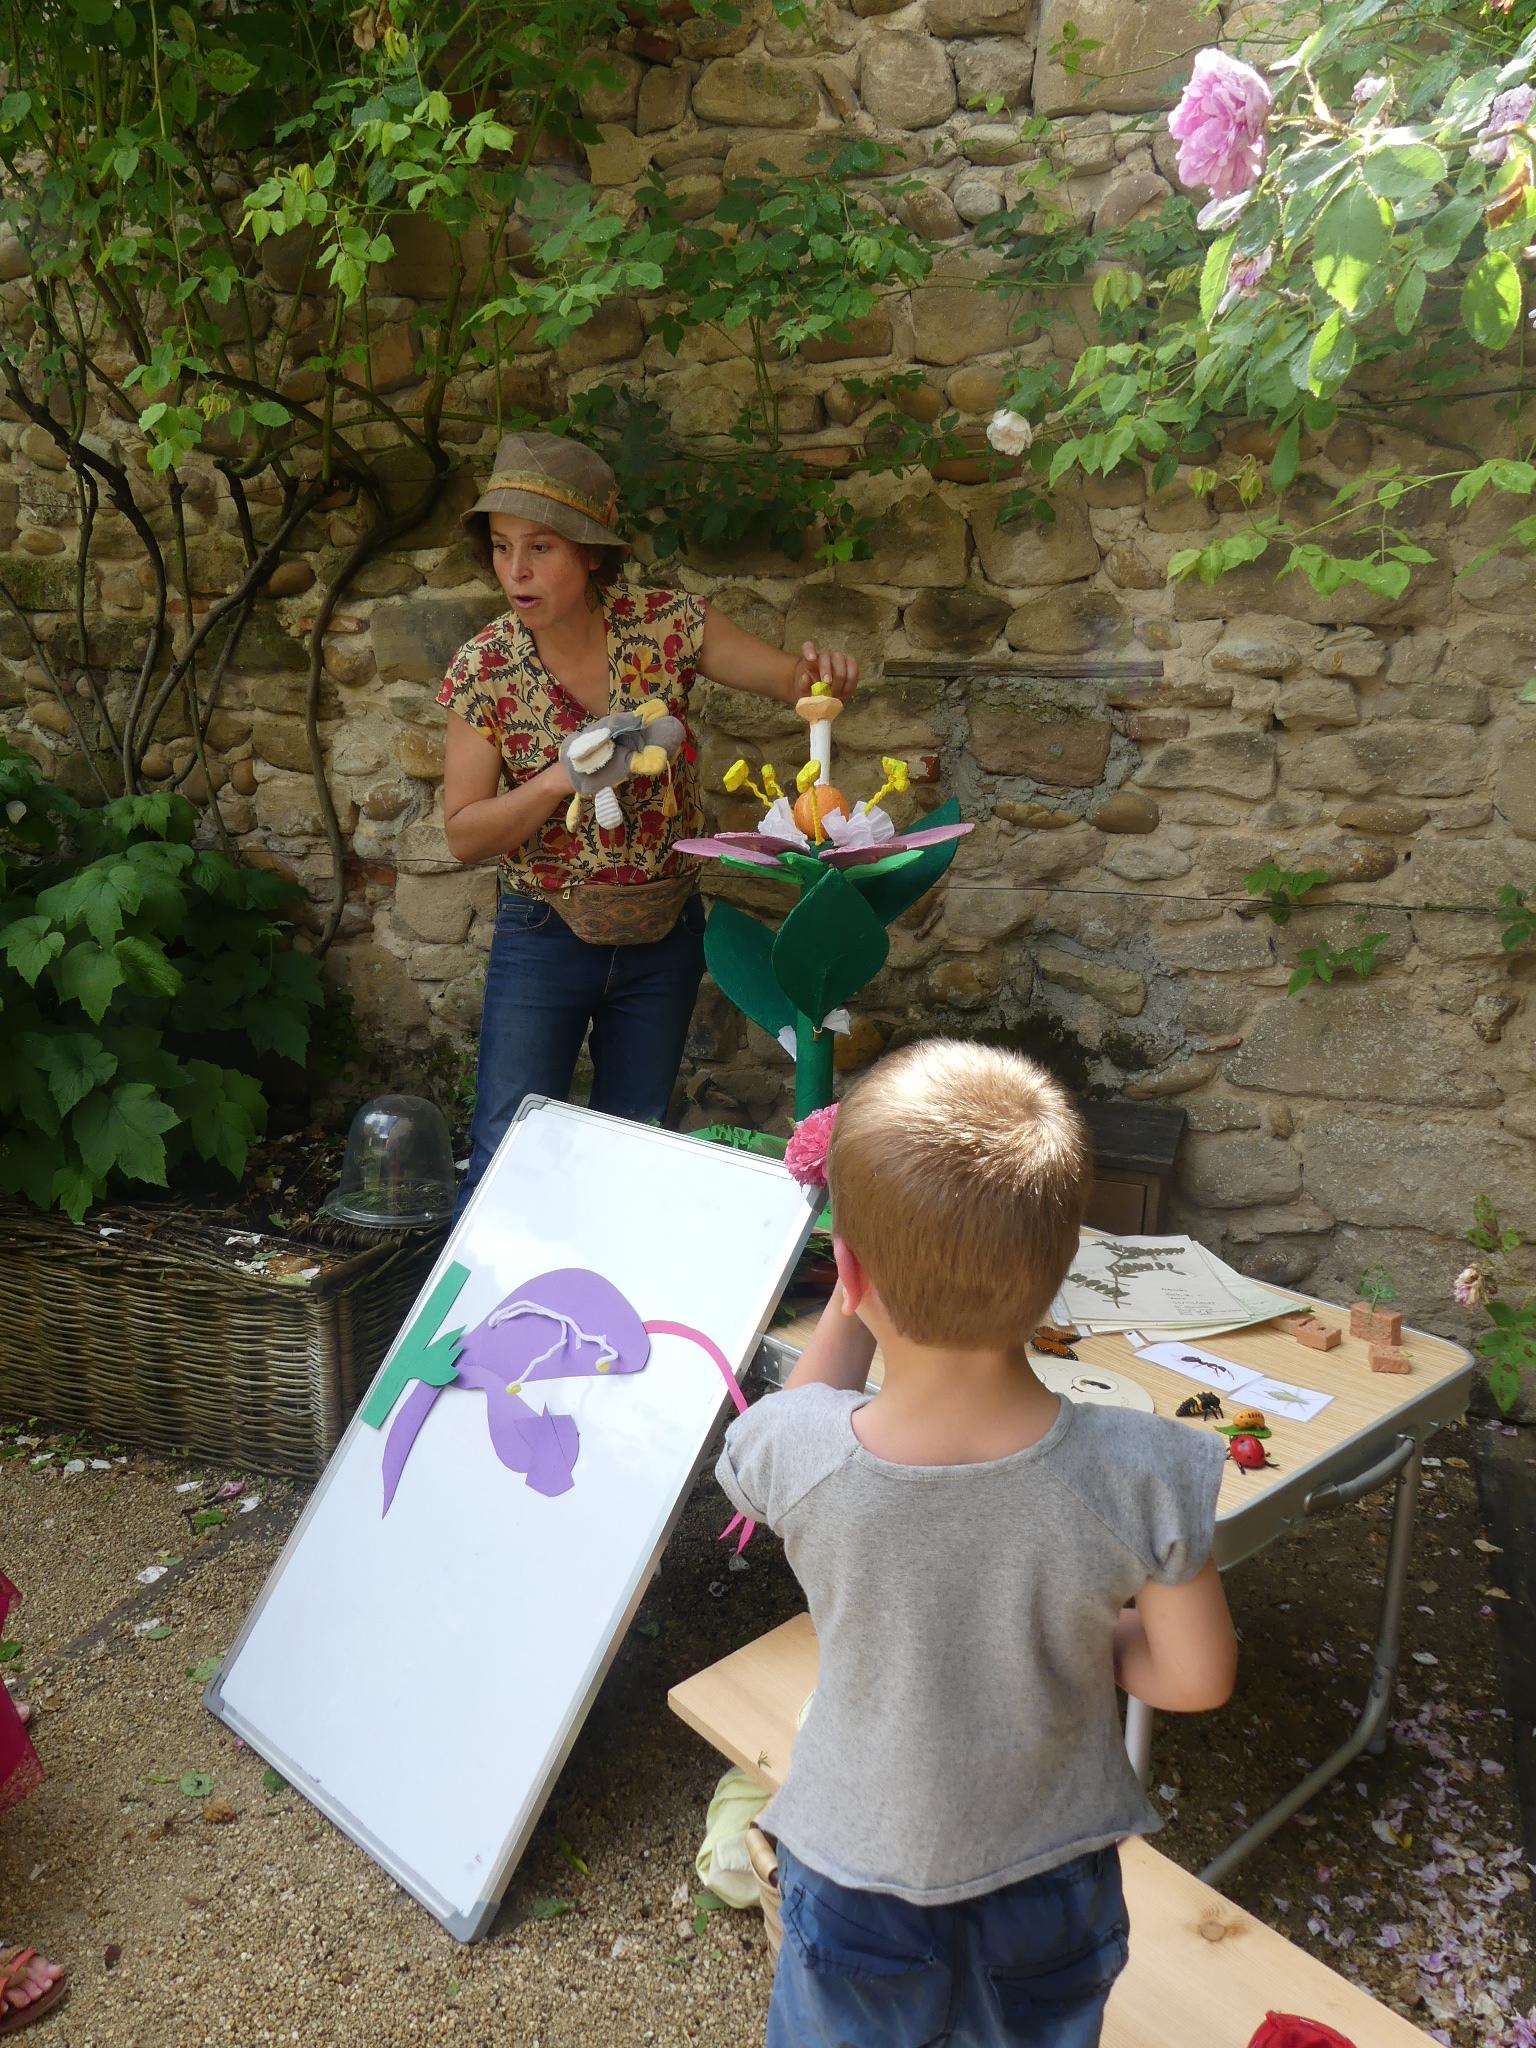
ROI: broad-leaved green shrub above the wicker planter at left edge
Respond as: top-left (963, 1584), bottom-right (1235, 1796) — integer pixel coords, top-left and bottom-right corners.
top-left (0, 739), bottom-right (322, 1223)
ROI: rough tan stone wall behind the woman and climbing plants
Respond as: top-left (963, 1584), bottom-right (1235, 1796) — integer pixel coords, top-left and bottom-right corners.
top-left (0, 0), bottom-right (1536, 1325)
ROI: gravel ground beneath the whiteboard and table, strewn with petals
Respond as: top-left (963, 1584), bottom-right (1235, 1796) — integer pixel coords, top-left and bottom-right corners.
top-left (0, 1430), bottom-right (1536, 2048)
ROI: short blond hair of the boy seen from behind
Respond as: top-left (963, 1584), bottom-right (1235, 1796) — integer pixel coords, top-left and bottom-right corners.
top-left (827, 1038), bottom-right (1092, 1350)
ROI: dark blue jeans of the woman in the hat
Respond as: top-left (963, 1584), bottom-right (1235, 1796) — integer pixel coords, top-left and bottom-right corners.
top-left (455, 895), bottom-right (705, 1214)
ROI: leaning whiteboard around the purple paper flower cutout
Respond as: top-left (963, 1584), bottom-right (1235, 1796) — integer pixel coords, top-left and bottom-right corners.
top-left (205, 1100), bottom-right (831, 1942)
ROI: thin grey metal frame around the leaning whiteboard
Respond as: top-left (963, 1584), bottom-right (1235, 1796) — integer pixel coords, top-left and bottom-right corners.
top-left (214, 1096), bottom-right (819, 1942)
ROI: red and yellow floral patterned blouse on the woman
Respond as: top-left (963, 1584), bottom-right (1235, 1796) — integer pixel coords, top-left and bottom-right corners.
top-left (438, 590), bottom-right (705, 895)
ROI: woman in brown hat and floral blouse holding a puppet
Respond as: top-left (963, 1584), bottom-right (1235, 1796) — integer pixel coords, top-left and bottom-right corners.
top-left (438, 434), bottom-right (858, 1206)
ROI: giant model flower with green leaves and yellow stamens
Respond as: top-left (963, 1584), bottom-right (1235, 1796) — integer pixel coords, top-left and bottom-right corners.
top-left (678, 692), bottom-right (973, 1118)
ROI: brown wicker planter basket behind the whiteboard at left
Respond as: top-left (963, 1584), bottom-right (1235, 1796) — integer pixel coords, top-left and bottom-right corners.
top-left (0, 1202), bottom-right (442, 1479)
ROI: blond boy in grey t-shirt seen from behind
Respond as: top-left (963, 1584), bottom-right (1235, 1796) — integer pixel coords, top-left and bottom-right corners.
top-left (719, 1040), bottom-right (1237, 2048)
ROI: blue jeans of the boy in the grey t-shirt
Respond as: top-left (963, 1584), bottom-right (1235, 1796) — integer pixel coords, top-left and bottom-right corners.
top-left (768, 1845), bottom-right (1128, 2048)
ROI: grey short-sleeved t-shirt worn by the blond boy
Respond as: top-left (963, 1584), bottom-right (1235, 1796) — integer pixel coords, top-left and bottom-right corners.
top-left (717, 1384), bottom-right (1227, 1905)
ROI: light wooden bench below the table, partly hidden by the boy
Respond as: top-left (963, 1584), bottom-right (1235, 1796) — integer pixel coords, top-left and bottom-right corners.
top-left (668, 1614), bottom-right (1427, 2048)
